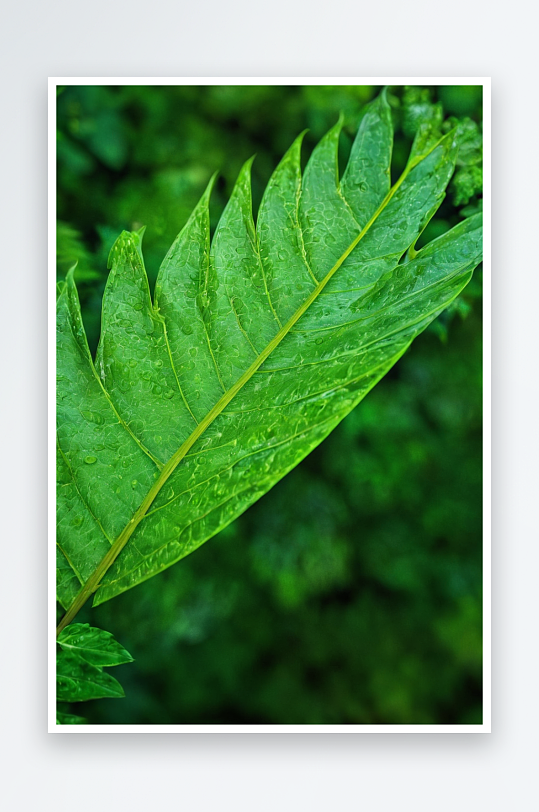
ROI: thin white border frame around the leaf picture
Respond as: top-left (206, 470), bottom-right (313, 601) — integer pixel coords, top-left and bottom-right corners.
top-left (48, 76), bottom-right (492, 733)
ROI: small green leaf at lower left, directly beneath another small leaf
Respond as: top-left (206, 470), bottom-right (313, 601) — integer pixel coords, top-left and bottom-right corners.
top-left (56, 650), bottom-right (125, 702)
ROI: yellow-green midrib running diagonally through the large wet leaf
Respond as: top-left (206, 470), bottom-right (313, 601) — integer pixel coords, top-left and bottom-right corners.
top-left (56, 138), bottom-right (451, 636)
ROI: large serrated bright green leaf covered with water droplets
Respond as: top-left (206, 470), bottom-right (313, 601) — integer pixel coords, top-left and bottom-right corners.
top-left (58, 94), bottom-right (482, 627)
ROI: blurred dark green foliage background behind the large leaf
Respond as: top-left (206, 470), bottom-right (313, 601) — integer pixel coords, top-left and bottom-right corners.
top-left (57, 86), bottom-right (482, 724)
